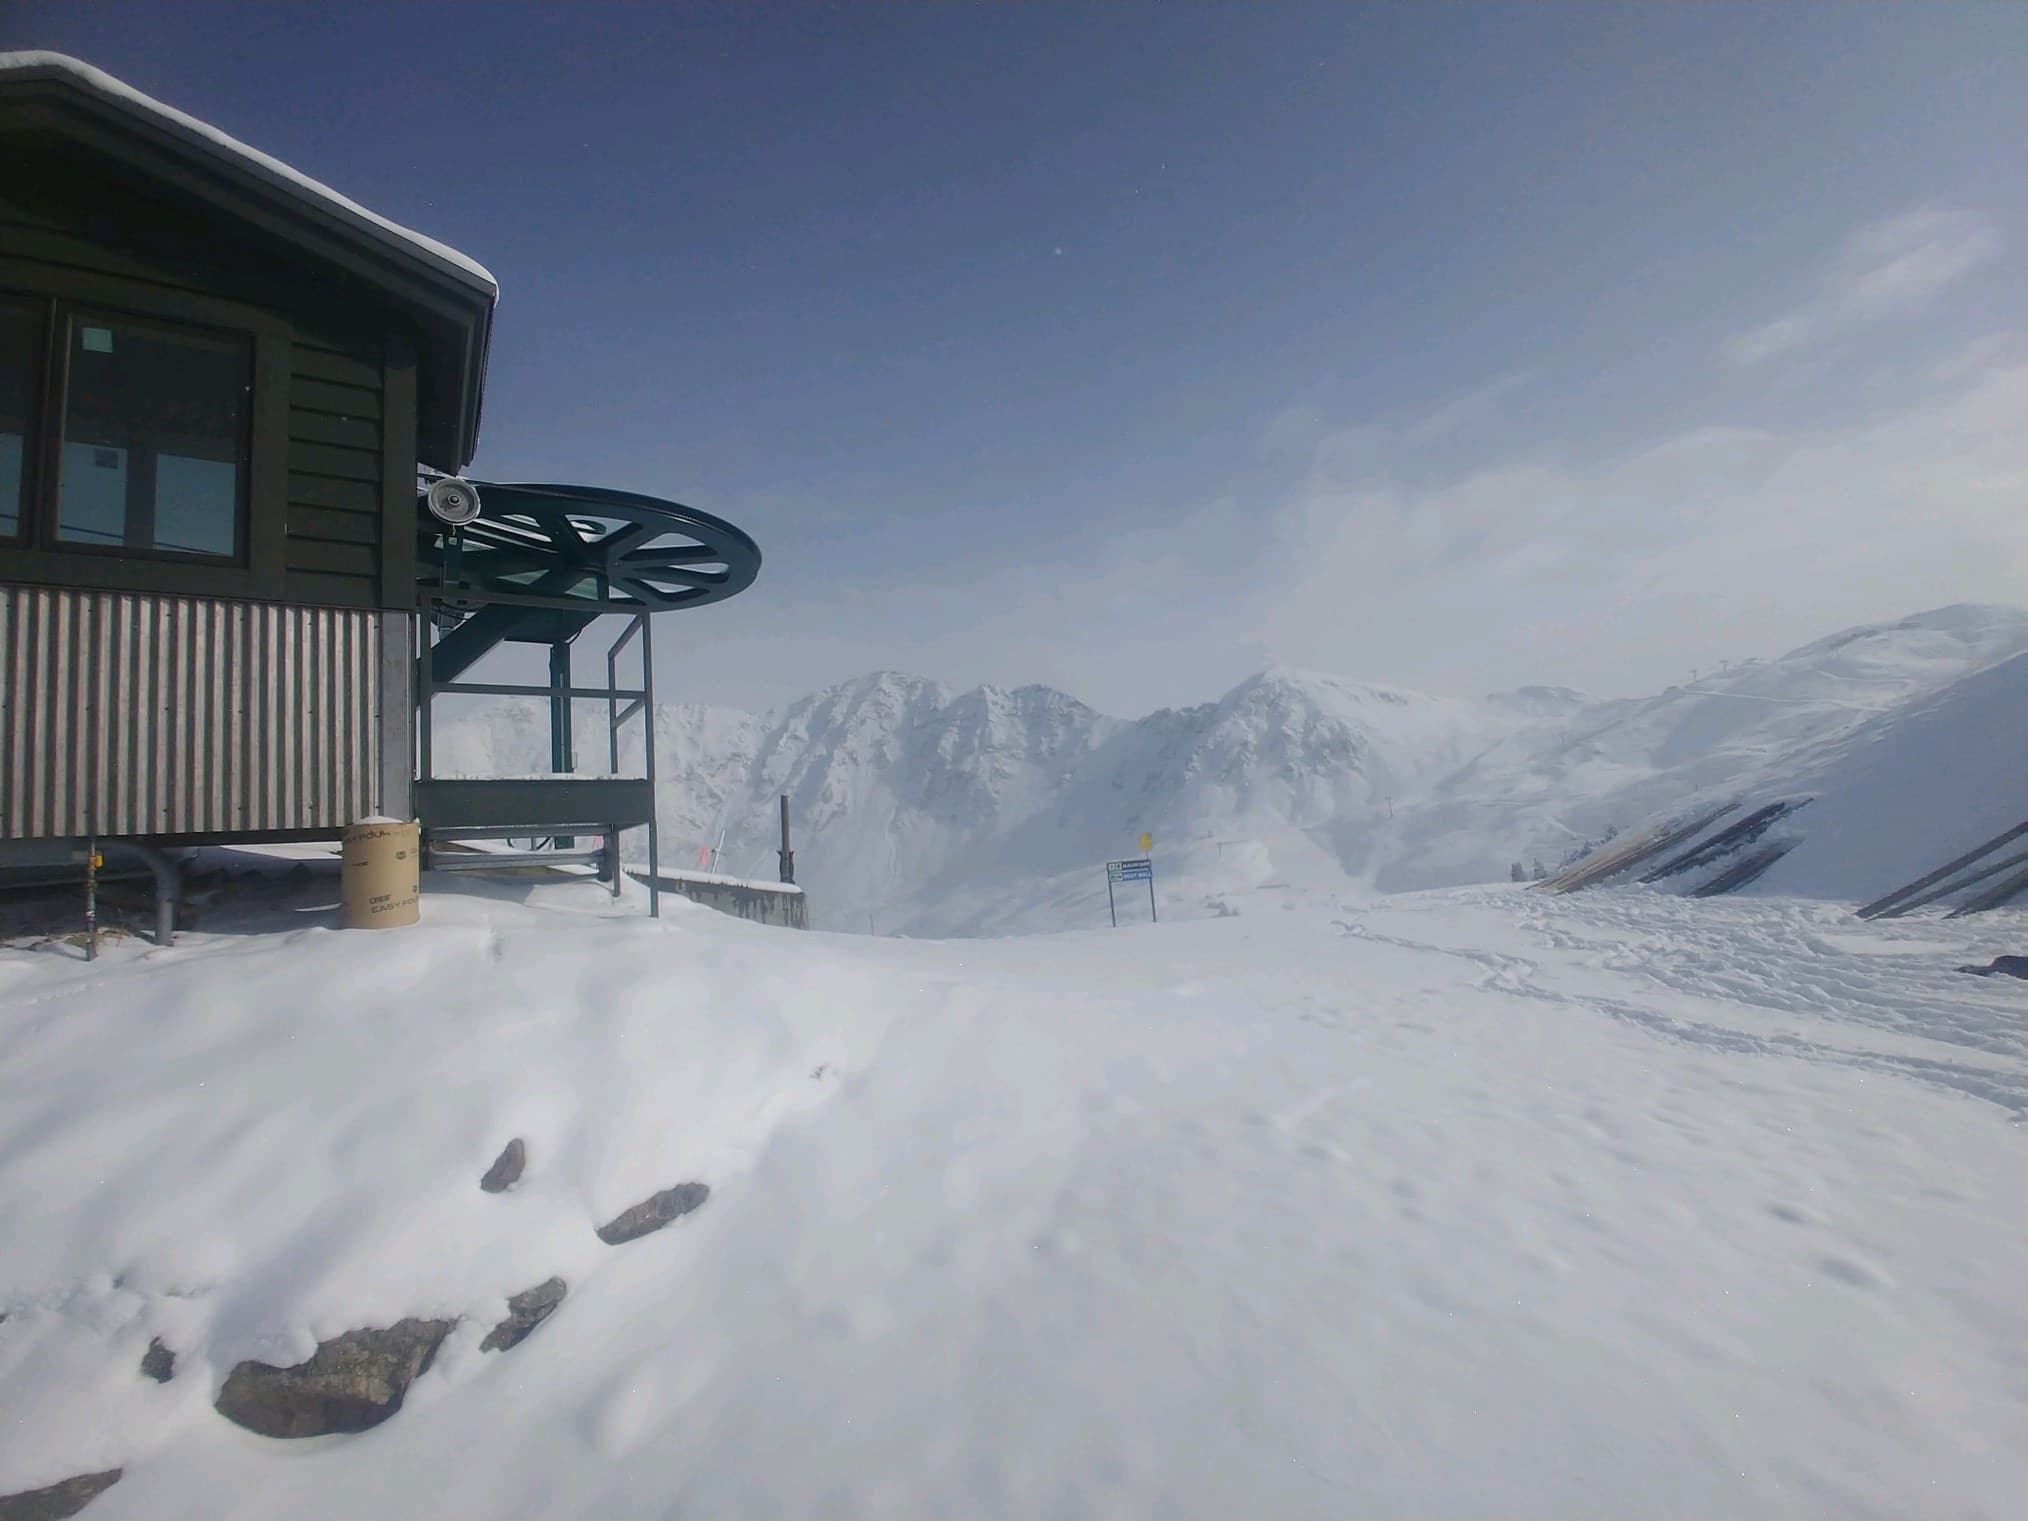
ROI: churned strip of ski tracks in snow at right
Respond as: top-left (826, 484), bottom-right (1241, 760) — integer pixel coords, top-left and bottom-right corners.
top-left (1332, 888), bottom-right (2028, 1124)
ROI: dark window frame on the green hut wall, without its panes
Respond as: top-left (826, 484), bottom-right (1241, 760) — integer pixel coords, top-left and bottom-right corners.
top-left (0, 258), bottom-right (292, 600)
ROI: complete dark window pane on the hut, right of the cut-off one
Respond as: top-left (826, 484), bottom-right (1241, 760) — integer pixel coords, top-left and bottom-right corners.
top-left (57, 314), bottom-right (251, 558)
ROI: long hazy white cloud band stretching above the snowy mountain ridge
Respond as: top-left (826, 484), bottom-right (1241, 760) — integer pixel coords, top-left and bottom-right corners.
top-left (669, 341), bottom-right (2028, 716)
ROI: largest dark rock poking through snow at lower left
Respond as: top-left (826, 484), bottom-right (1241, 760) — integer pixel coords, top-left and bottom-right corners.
top-left (215, 1318), bottom-right (456, 1436)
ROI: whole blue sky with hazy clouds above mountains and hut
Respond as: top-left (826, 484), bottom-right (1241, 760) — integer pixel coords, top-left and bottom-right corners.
top-left (4, 0), bottom-right (2028, 714)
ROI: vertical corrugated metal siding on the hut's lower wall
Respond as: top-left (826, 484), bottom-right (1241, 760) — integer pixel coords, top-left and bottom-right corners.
top-left (0, 586), bottom-right (383, 840)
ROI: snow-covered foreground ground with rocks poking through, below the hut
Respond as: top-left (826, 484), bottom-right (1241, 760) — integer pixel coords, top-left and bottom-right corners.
top-left (0, 876), bottom-right (2028, 1521)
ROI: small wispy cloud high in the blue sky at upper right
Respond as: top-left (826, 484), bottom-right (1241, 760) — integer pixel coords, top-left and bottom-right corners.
top-left (1720, 207), bottom-right (1998, 367)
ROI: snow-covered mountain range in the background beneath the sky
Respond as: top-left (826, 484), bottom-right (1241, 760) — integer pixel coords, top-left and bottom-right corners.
top-left (436, 606), bottom-right (2028, 935)
